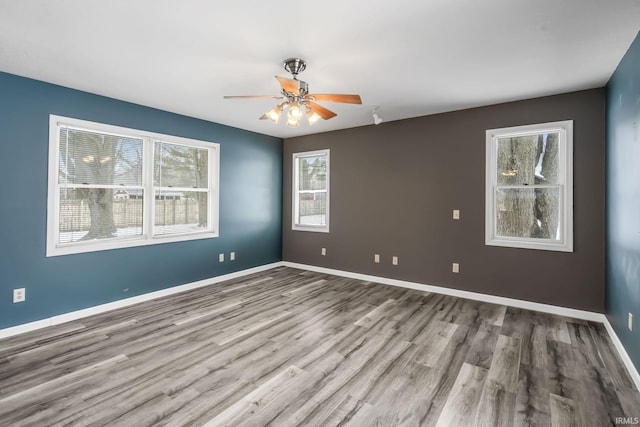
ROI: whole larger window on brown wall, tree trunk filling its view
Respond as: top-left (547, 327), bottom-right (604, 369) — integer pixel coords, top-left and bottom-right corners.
top-left (485, 120), bottom-right (573, 252)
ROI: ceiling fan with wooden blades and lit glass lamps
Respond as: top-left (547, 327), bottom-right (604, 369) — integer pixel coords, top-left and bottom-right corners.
top-left (224, 58), bottom-right (362, 128)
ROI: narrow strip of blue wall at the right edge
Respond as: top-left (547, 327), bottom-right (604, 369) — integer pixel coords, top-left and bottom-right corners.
top-left (605, 35), bottom-right (640, 369)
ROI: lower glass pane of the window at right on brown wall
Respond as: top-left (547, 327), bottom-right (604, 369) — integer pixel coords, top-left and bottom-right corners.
top-left (496, 188), bottom-right (560, 240)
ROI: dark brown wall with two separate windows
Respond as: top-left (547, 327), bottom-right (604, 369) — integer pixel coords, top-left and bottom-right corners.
top-left (283, 89), bottom-right (605, 312)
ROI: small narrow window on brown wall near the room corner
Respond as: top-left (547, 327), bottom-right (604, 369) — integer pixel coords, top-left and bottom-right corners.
top-left (292, 150), bottom-right (329, 233)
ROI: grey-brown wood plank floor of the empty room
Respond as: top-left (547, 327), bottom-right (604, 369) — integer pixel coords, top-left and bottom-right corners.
top-left (0, 267), bottom-right (640, 427)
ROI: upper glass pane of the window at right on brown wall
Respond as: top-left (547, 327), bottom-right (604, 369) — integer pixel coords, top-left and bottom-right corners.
top-left (496, 132), bottom-right (559, 185)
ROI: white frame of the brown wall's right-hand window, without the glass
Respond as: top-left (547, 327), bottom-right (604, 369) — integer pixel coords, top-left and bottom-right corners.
top-left (485, 120), bottom-right (573, 252)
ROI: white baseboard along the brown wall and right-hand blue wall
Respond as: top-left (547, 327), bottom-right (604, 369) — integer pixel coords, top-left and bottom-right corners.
top-left (283, 261), bottom-right (640, 390)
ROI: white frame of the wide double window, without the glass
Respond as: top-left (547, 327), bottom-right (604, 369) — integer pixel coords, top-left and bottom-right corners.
top-left (46, 114), bottom-right (220, 257)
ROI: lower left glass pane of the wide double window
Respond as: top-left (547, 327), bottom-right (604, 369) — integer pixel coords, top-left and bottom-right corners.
top-left (58, 188), bottom-right (143, 243)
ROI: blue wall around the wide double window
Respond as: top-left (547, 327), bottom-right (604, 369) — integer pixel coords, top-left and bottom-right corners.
top-left (0, 73), bottom-right (282, 329)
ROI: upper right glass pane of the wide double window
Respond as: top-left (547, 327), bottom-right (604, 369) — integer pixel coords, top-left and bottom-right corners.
top-left (153, 141), bottom-right (209, 188)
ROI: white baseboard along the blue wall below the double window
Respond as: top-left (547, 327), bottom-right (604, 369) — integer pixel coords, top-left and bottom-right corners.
top-left (0, 262), bottom-right (283, 338)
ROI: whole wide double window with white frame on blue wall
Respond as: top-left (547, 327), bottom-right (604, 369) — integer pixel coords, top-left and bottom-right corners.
top-left (47, 115), bottom-right (219, 256)
